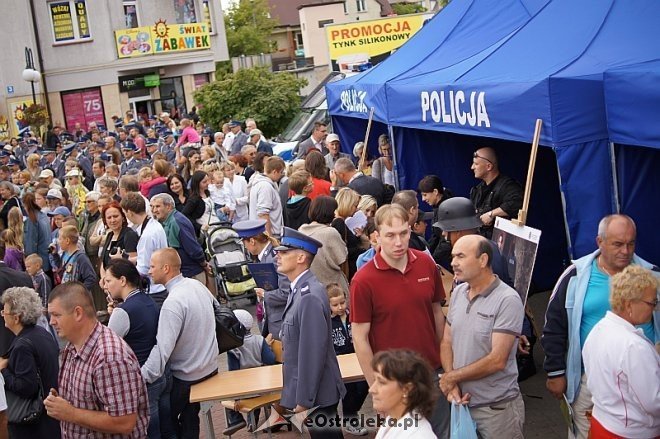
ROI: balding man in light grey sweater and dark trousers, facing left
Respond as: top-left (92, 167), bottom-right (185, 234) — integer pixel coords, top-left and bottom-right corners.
top-left (142, 248), bottom-right (218, 438)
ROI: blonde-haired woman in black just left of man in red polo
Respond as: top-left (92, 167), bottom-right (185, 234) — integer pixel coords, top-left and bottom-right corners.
top-left (330, 187), bottom-right (364, 282)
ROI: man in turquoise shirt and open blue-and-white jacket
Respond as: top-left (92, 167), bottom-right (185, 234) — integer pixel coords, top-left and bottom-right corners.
top-left (541, 215), bottom-right (660, 439)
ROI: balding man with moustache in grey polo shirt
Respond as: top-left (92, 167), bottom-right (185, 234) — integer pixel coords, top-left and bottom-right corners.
top-left (440, 235), bottom-right (525, 439)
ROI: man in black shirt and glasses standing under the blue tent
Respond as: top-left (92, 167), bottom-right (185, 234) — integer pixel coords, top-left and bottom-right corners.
top-left (470, 147), bottom-right (523, 239)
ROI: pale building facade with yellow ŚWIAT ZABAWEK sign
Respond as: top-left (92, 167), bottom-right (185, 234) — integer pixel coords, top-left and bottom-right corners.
top-left (0, 0), bottom-right (229, 136)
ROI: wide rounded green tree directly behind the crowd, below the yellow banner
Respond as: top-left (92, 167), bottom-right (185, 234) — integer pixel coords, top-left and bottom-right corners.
top-left (194, 67), bottom-right (307, 136)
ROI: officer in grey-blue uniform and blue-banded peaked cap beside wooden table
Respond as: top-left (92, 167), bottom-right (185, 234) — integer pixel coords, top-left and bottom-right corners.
top-left (275, 227), bottom-right (346, 438)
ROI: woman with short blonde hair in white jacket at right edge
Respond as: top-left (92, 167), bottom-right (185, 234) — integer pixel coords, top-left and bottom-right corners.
top-left (582, 265), bottom-right (660, 439)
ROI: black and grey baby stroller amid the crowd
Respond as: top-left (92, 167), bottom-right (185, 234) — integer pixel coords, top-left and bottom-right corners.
top-left (204, 222), bottom-right (257, 304)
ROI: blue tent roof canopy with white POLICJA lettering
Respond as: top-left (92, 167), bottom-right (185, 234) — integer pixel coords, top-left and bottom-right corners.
top-left (328, 0), bottom-right (660, 146)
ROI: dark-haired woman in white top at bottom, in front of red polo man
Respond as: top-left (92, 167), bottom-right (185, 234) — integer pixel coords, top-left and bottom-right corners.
top-left (369, 349), bottom-right (436, 439)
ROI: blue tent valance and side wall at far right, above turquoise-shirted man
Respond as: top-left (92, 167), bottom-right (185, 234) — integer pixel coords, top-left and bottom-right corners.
top-left (604, 60), bottom-right (660, 264)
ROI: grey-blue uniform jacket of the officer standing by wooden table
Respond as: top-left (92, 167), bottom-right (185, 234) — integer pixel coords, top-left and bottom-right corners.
top-left (280, 270), bottom-right (346, 409)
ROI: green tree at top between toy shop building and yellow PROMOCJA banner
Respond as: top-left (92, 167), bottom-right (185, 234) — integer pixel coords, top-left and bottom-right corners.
top-left (225, 0), bottom-right (276, 57)
